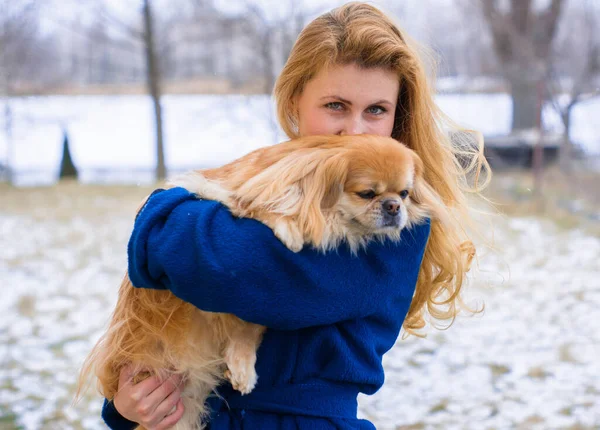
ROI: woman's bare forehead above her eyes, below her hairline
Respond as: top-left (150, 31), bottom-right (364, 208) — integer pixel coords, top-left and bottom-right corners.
top-left (303, 64), bottom-right (400, 103)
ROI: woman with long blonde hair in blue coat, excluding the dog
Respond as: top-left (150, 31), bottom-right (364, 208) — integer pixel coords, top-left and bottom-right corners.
top-left (103, 3), bottom-right (485, 430)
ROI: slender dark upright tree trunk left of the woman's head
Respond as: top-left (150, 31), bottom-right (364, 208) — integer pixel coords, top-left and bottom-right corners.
top-left (144, 0), bottom-right (167, 181)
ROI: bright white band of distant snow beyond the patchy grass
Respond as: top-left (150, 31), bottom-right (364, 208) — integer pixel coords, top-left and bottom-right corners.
top-left (0, 94), bottom-right (600, 185)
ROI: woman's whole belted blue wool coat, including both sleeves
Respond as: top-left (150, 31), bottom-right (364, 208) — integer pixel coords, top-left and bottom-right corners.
top-left (103, 188), bottom-right (430, 430)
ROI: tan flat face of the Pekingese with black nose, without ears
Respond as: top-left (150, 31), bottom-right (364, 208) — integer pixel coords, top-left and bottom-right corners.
top-left (334, 138), bottom-right (419, 234)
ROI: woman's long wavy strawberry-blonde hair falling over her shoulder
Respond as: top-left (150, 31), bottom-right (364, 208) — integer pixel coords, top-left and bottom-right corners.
top-left (274, 2), bottom-right (490, 334)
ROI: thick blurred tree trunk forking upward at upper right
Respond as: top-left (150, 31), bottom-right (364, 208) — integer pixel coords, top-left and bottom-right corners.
top-left (479, 0), bottom-right (564, 131)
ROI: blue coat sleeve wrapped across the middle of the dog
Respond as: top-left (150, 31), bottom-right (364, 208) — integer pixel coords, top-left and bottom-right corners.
top-left (128, 188), bottom-right (430, 330)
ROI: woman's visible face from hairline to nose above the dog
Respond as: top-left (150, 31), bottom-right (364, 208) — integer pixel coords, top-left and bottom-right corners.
top-left (297, 64), bottom-right (400, 136)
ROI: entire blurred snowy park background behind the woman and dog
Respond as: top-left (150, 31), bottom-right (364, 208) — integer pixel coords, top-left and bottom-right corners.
top-left (0, 0), bottom-right (600, 430)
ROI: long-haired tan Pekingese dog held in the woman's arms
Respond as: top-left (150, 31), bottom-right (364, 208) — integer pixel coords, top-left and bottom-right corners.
top-left (80, 135), bottom-right (444, 430)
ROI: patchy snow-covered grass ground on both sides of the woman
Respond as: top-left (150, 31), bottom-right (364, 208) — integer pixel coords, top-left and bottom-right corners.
top-left (0, 184), bottom-right (600, 430)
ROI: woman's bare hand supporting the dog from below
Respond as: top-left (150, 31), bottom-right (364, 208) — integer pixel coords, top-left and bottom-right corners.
top-left (114, 366), bottom-right (184, 430)
